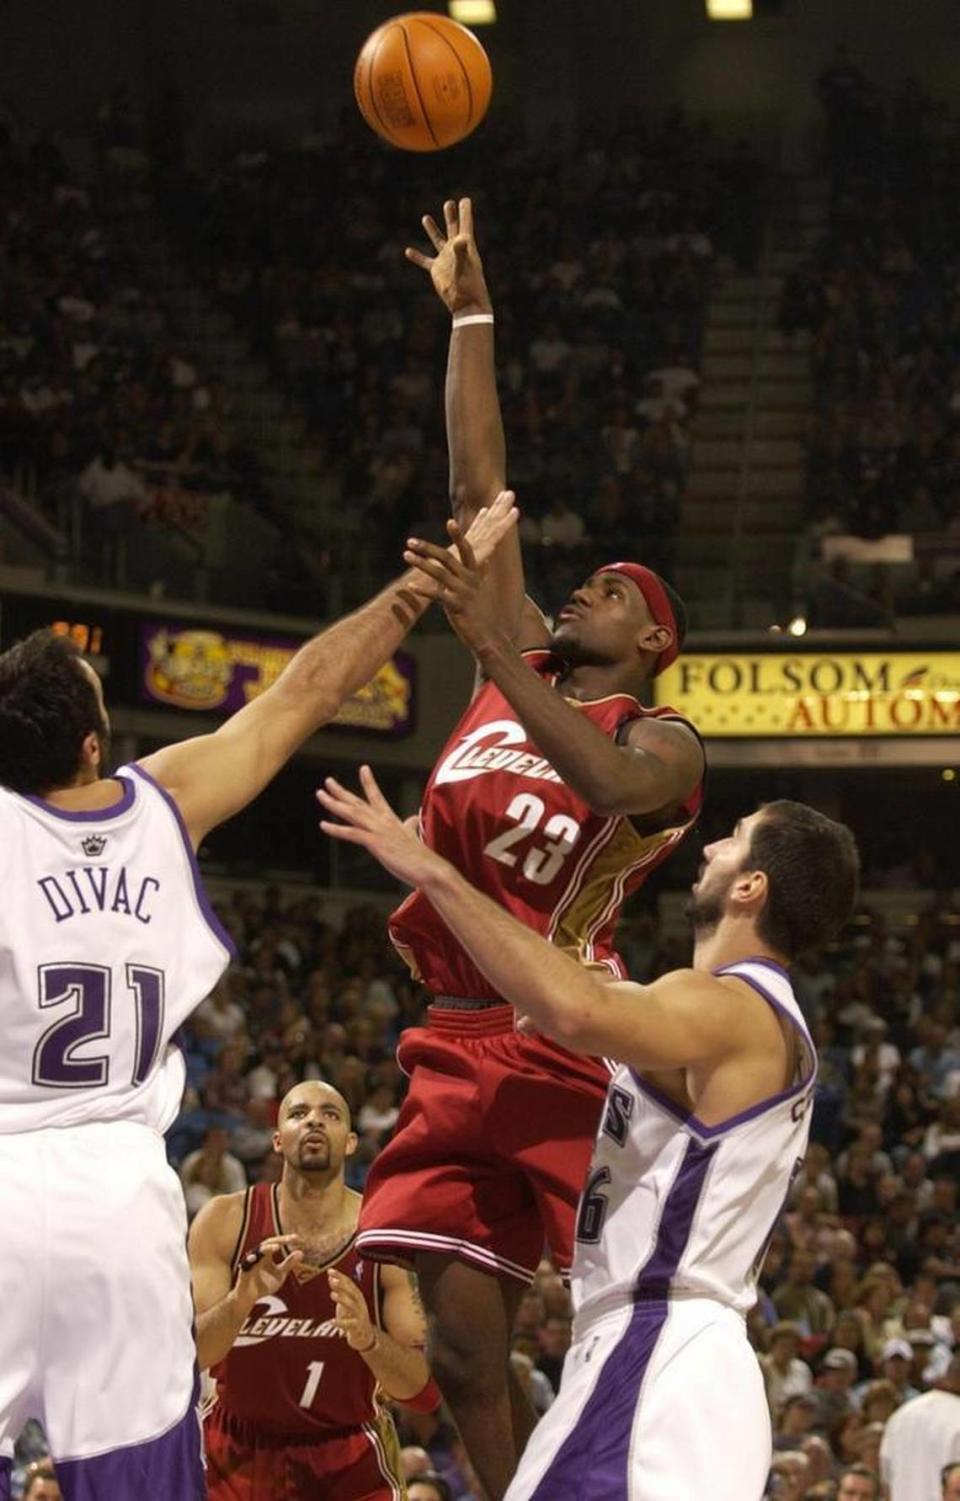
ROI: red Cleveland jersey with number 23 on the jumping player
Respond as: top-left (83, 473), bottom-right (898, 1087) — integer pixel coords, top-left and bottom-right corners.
top-left (390, 650), bottom-right (704, 1000)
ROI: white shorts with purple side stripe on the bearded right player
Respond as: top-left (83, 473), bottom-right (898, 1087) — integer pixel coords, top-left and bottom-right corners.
top-left (506, 1298), bottom-right (771, 1501)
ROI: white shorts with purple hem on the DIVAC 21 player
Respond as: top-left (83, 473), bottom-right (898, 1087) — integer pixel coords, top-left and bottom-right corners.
top-left (0, 1121), bottom-right (204, 1501)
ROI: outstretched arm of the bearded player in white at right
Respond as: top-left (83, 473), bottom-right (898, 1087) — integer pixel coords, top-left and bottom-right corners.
top-left (317, 767), bottom-right (753, 1070)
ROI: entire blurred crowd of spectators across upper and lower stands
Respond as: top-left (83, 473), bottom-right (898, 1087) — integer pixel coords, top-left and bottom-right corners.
top-left (0, 29), bottom-right (960, 1501)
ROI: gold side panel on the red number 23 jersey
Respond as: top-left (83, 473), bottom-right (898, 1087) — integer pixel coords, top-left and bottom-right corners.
top-left (549, 817), bottom-right (690, 964)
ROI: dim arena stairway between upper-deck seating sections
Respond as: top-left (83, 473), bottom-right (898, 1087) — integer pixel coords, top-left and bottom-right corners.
top-left (677, 177), bottom-right (827, 629)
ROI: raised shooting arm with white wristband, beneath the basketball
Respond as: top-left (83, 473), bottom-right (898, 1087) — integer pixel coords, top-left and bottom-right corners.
top-left (407, 198), bottom-right (546, 647)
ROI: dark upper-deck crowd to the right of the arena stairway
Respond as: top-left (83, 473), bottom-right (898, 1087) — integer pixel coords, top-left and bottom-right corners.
top-left (780, 48), bottom-right (960, 626)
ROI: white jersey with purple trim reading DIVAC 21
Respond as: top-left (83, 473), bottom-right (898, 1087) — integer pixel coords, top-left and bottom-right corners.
top-left (0, 766), bottom-right (233, 1133)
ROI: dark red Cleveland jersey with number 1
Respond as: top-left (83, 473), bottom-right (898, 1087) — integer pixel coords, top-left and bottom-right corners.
top-left (210, 1183), bottom-right (381, 1438)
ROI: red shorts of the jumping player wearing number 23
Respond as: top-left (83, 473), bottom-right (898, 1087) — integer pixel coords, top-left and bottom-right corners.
top-left (357, 1006), bottom-right (609, 1282)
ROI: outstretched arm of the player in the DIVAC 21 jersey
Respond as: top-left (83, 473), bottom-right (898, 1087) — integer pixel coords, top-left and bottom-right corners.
top-left (141, 492), bottom-right (516, 847)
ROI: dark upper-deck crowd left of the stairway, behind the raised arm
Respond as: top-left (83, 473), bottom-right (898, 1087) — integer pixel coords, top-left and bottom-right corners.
top-left (0, 90), bottom-right (765, 611)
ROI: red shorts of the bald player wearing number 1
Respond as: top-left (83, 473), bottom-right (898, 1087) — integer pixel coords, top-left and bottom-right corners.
top-left (204, 1402), bottom-right (405, 1501)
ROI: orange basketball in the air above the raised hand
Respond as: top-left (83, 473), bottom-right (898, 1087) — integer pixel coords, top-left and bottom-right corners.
top-left (354, 11), bottom-right (494, 152)
